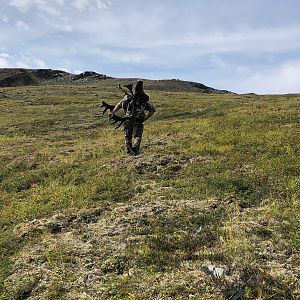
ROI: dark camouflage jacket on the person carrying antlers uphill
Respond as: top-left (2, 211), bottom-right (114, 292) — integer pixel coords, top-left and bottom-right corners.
top-left (120, 93), bottom-right (155, 122)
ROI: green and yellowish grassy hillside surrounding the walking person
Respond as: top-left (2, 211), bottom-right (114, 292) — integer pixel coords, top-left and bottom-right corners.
top-left (0, 80), bottom-right (300, 299)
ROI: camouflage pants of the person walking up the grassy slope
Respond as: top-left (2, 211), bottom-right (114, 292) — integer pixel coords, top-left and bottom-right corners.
top-left (124, 120), bottom-right (144, 154)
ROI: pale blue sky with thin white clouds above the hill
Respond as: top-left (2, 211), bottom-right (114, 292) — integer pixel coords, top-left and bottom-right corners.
top-left (0, 0), bottom-right (300, 94)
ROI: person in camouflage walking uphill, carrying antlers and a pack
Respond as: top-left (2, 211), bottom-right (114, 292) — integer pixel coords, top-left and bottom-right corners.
top-left (109, 80), bottom-right (155, 155)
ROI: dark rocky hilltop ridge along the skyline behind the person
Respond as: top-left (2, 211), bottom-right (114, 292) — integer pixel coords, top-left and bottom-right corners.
top-left (0, 69), bottom-right (229, 94)
